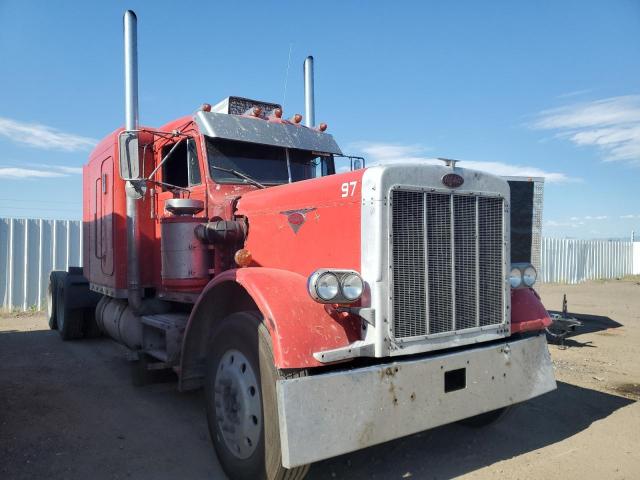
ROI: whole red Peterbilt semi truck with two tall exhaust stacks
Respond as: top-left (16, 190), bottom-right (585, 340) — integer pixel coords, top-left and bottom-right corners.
top-left (49, 11), bottom-right (556, 479)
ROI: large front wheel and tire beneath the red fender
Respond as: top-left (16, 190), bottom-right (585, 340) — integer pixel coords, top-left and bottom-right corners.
top-left (204, 312), bottom-right (309, 480)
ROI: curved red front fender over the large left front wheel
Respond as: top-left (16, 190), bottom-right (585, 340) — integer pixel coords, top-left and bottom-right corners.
top-left (183, 267), bottom-right (361, 374)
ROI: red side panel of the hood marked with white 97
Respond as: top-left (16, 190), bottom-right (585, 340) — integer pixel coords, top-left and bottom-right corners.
top-left (237, 170), bottom-right (364, 278)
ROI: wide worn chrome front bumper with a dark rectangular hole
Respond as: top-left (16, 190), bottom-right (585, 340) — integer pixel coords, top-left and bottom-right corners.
top-left (277, 335), bottom-right (556, 468)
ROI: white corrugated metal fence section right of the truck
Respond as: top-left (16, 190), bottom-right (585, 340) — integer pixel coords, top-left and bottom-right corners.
top-left (539, 238), bottom-right (640, 283)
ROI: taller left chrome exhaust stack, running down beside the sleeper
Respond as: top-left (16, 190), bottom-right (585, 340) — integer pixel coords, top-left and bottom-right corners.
top-left (124, 10), bottom-right (144, 313)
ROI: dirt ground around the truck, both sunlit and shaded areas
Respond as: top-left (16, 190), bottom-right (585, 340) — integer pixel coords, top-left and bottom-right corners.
top-left (0, 280), bottom-right (640, 480)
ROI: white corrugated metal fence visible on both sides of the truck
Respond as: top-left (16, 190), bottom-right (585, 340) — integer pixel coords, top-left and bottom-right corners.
top-left (0, 218), bottom-right (640, 310)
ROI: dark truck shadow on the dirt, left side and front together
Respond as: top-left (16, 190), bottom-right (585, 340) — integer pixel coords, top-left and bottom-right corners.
top-left (0, 330), bottom-right (633, 480)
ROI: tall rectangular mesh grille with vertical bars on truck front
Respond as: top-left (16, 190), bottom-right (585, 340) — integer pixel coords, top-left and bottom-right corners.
top-left (391, 189), bottom-right (504, 338)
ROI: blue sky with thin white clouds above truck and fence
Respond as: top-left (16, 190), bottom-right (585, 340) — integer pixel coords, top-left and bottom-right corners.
top-left (0, 0), bottom-right (640, 238)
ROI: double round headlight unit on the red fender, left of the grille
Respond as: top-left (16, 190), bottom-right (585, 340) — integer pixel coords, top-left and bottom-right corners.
top-left (307, 268), bottom-right (364, 304)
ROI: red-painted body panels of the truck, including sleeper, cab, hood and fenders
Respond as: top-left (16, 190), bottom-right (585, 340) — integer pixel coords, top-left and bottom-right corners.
top-left (83, 109), bottom-right (551, 368)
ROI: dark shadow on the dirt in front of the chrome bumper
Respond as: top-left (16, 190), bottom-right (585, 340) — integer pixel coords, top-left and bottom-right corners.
top-left (309, 382), bottom-right (634, 480)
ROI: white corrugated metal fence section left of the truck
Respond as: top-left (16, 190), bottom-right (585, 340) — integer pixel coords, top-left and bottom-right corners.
top-left (0, 218), bottom-right (82, 310)
